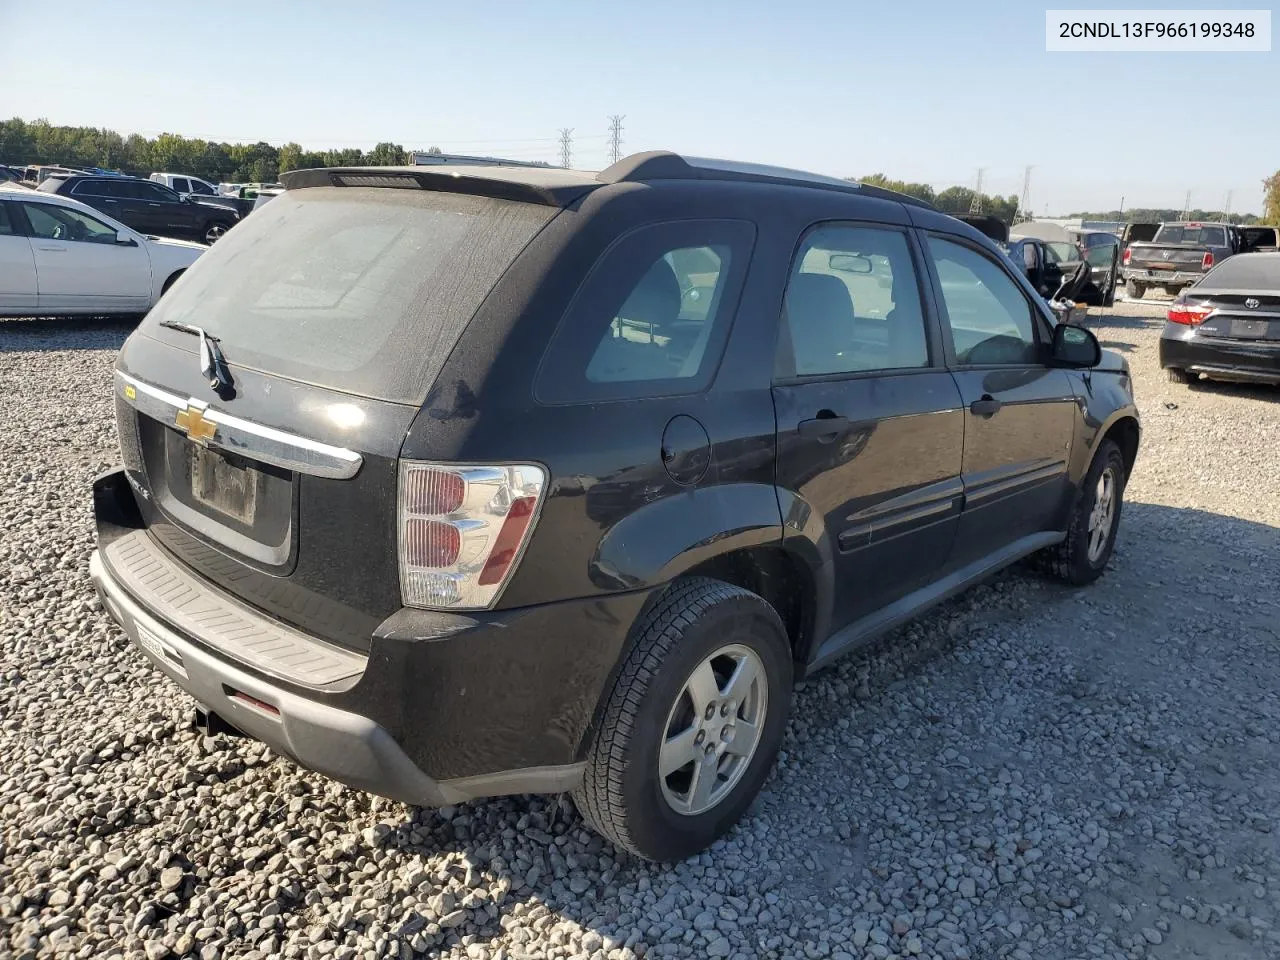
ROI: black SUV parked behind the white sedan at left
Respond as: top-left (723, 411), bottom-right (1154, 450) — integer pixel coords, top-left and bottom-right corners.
top-left (38, 174), bottom-right (239, 243)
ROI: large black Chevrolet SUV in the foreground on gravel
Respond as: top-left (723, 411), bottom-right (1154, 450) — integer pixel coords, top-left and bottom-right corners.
top-left (91, 152), bottom-right (1139, 859)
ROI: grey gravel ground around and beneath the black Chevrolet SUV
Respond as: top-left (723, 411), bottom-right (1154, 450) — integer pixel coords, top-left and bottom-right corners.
top-left (0, 303), bottom-right (1280, 960)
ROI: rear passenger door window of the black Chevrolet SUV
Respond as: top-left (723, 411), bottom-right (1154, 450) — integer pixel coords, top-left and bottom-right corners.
top-left (778, 225), bottom-right (929, 376)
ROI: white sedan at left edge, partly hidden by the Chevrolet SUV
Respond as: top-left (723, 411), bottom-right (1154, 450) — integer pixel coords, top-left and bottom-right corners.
top-left (0, 184), bottom-right (209, 316)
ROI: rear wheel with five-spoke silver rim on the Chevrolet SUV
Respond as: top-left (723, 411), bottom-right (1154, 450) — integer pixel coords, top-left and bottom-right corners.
top-left (573, 577), bottom-right (792, 861)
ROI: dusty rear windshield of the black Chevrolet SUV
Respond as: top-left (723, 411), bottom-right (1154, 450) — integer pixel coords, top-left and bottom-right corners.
top-left (142, 187), bottom-right (557, 404)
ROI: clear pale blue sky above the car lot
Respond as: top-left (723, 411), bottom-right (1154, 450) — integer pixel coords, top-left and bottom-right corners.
top-left (0, 0), bottom-right (1280, 214)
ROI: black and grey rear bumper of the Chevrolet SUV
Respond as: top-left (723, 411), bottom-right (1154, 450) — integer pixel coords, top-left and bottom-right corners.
top-left (90, 470), bottom-right (649, 805)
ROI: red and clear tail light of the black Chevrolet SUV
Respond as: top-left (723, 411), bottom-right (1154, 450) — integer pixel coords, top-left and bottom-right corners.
top-left (398, 460), bottom-right (547, 609)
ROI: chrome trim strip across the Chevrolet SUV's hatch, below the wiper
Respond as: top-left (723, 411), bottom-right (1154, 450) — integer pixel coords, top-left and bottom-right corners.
top-left (115, 370), bottom-right (365, 480)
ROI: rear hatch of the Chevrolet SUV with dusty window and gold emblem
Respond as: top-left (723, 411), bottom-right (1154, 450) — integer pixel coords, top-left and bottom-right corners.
top-left (116, 187), bottom-right (556, 648)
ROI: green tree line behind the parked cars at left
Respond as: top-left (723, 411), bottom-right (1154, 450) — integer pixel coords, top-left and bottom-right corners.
top-left (0, 118), bottom-right (440, 183)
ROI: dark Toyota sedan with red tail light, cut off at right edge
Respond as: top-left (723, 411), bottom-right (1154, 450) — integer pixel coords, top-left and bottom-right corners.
top-left (1160, 253), bottom-right (1280, 383)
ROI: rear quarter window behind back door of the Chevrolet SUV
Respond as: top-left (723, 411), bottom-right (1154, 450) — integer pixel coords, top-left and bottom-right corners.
top-left (536, 220), bottom-right (755, 403)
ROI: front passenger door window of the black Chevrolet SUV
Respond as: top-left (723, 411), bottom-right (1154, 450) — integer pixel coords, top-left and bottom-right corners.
top-left (929, 237), bottom-right (1039, 365)
